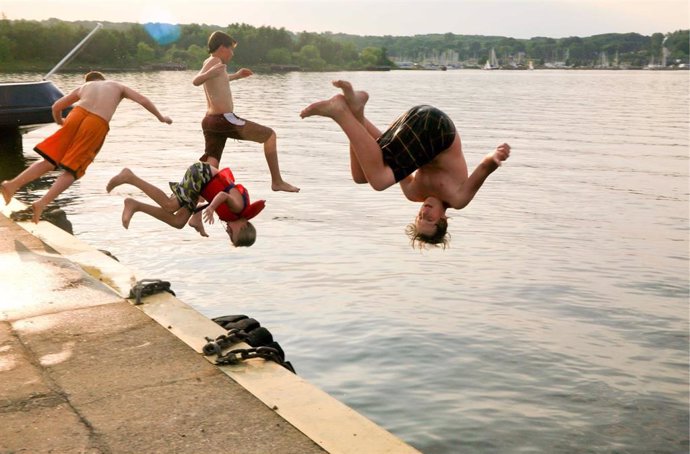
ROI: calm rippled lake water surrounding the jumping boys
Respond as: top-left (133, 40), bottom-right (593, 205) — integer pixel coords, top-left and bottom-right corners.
top-left (2, 70), bottom-right (690, 454)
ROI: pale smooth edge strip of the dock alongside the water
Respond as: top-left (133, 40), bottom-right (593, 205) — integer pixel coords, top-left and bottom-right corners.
top-left (0, 199), bottom-right (419, 454)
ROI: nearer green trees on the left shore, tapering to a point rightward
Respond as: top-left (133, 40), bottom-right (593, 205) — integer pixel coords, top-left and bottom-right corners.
top-left (0, 19), bottom-right (393, 71)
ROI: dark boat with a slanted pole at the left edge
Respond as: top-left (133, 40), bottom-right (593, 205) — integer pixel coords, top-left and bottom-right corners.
top-left (0, 24), bottom-right (103, 134)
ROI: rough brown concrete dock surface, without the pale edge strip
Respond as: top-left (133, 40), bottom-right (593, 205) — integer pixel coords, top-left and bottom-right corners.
top-left (0, 215), bottom-right (325, 454)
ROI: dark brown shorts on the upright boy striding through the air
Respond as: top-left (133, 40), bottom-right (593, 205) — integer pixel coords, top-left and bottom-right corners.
top-left (199, 113), bottom-right (273, 161)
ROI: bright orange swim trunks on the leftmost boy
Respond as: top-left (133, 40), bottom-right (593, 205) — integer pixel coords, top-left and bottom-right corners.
top-left (34, 106), bottom-right (110, 179)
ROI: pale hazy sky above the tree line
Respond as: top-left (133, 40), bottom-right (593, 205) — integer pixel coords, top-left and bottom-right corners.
top-left (0, 0), bottom-right (690, 38)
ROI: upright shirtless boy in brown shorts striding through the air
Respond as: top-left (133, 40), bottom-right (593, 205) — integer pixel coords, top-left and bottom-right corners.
top-left (192, 31), bottom-right (299, 192)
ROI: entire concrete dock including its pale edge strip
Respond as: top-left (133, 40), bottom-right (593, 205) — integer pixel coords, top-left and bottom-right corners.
top-left (0, 199), bottom-right (417, 454)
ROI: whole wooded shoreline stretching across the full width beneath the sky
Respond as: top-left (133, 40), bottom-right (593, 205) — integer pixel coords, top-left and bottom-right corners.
top-left (0, 16), bottom-right (690, 71)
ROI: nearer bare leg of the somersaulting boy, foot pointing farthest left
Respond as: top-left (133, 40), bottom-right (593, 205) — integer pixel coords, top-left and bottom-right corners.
top-left (300, 95), bottom-right (395, 191)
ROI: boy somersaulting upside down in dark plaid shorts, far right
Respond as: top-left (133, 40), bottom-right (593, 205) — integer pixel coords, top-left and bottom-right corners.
top-left (300, 80), bottom-right (510, 248)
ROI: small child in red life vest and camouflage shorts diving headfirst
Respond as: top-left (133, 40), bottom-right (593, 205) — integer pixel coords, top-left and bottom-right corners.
top-left (105, 162), bottom-right (264, 247)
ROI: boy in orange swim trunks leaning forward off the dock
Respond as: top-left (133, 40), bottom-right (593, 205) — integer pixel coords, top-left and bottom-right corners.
top-left (0, 71), bottom-right (172, 223)
